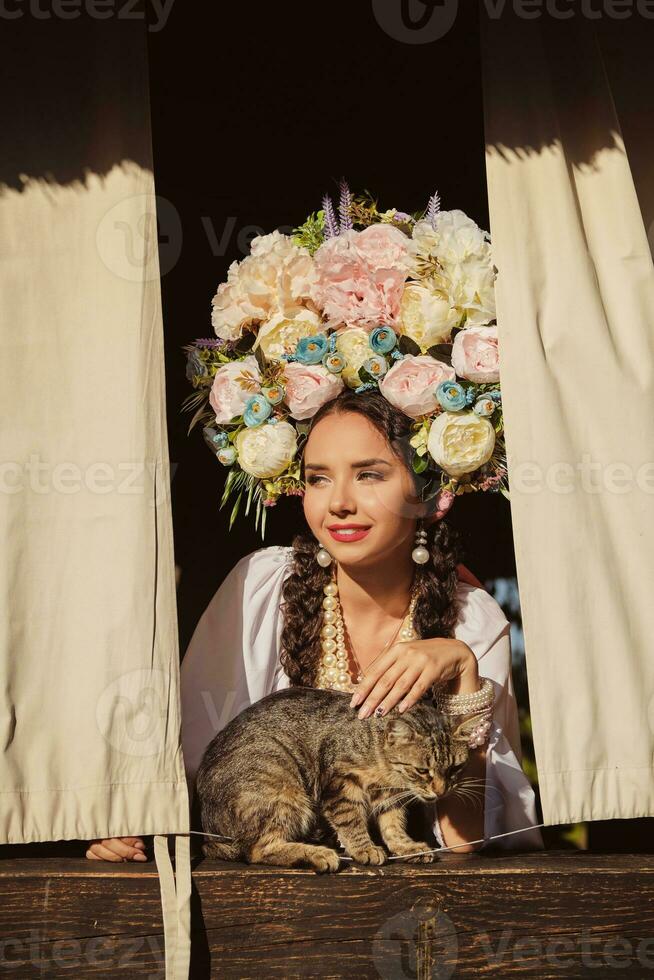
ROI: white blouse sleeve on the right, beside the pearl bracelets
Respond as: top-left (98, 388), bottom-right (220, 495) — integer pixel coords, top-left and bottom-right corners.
top-left (434, 582), bottom-right (544, 853)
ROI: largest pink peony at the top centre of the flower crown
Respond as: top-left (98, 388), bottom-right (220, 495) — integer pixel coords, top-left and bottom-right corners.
top-left (312, 225), bottom-right (415, 330)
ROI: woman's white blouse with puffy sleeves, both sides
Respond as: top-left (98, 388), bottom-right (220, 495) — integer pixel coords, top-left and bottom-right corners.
top-left (181, 545), bottom-right (544, 853)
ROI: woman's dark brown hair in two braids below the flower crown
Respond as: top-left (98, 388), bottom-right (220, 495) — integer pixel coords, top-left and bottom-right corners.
top-left (281, 388), bottom-right (461, 687)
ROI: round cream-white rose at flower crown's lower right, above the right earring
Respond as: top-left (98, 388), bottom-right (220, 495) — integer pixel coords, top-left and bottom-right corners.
top-left (427, 409), bottom-right (495, 476)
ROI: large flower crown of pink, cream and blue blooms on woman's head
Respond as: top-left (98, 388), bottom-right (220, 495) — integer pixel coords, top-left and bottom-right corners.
top-left (183, 180), bottom-right (509, 539)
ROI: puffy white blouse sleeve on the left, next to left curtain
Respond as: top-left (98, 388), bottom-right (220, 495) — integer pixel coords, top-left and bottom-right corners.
top-left (181, 546), bottom-right (292, 795)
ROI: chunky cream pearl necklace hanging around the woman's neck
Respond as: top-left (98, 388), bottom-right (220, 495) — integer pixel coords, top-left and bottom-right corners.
top-left (316, 575), bottom-right (418, 692)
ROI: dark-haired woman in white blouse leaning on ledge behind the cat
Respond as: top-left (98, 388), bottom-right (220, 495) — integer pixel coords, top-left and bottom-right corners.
top-left (87, 390), bottom-right (543, 860)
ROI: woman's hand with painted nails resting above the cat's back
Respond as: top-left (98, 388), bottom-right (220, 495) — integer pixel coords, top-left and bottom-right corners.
top-left (350, 637), bottom-right (479, 718)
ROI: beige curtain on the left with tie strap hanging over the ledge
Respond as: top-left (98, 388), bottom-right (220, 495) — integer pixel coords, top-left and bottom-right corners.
top-left (0, 21), bottom-right (190, 980)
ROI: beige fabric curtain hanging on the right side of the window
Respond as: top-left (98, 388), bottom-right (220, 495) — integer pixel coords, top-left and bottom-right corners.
top-left (482, 15), bottom-right (654, 824)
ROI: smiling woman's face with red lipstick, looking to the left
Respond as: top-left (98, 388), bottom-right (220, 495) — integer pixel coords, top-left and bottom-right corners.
top-left (304, 412), bottom-right (422, 565)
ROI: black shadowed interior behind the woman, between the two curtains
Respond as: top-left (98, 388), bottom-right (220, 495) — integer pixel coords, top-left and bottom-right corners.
top-left (148, 0), bottom-right (515, 652)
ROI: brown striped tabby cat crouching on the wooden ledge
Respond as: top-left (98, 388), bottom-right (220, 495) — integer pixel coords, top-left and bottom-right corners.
top-left (196, 687), bottom-right (474, 872)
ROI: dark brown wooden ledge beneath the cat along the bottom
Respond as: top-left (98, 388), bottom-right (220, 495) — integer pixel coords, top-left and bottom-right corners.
top-left (0, 848), bottom-right (654, 980)
